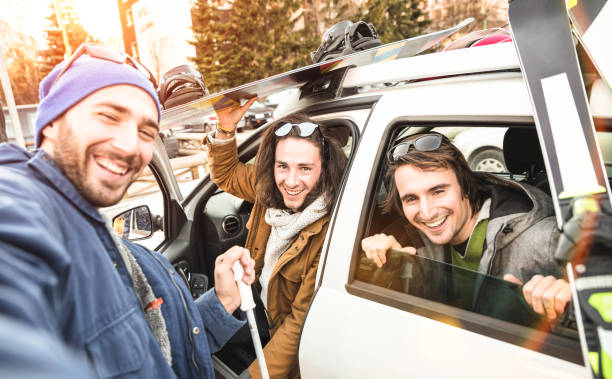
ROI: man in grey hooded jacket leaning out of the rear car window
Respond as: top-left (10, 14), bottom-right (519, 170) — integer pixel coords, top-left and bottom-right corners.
top-left (361, 132), bottom-right (571, 319)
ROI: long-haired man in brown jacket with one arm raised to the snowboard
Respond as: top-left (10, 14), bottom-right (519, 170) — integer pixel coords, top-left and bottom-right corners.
top-left (207, 105), bottom-right (347, 378)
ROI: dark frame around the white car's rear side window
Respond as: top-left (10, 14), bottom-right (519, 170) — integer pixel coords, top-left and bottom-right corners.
top-left (345, 121), bottom-right (584, 365)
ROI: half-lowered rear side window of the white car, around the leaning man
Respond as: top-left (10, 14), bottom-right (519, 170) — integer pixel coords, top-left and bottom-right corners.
top-left (349, 124), bottom-right (581, 362)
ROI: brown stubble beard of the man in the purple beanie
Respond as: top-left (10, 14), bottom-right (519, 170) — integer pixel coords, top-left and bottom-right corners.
top-left (53, 121), bottom-right (140, 208)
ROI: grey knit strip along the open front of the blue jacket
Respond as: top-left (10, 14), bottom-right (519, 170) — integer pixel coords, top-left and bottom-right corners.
top-left (106, 222), bottom-right (172, 366)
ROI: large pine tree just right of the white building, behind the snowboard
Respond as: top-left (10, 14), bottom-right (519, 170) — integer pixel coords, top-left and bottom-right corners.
top-left (192, 0), bottom-right (320, 92)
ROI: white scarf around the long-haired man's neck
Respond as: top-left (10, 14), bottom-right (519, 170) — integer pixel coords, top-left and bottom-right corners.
top-left (259, 195), bottom-right (327, 308)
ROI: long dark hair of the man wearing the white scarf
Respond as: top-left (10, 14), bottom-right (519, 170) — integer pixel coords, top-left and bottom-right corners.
top-left (255, 114), bottom-right (347, 213)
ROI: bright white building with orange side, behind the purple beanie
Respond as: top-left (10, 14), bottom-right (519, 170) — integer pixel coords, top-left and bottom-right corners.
top-left (117, 0), bottom-right (195, 79)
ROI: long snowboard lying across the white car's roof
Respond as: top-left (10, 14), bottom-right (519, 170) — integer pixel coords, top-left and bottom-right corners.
top-left (161, 18), bottom-right (474, 129)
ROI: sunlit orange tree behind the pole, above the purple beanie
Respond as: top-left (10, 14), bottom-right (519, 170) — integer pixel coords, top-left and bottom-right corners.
top-left (38, 2), bottom-right (96, 78)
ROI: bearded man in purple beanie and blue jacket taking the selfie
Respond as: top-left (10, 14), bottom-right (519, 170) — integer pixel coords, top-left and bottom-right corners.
top-left (0, 45), bottom-right (254, 378)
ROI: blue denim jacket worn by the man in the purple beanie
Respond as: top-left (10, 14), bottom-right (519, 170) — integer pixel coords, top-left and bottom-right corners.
top-left (0, 144), bottom-right (244, 378)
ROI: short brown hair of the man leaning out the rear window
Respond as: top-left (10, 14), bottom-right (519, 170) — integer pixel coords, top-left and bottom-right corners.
top-left (382, 136), bottom-right (490, 214)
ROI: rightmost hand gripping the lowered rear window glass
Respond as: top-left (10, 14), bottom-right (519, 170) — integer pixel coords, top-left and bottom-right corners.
top-left (504, 274), bottom-right (572, 320)
